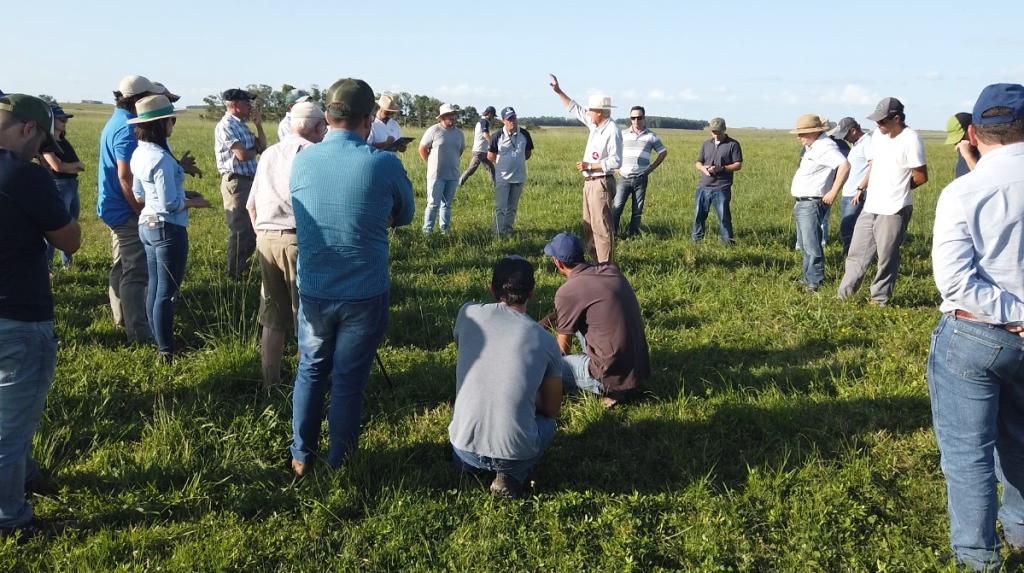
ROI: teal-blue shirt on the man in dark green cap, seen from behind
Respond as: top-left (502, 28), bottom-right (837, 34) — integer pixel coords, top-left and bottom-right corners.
top-left (289, 129), bottom-right (416, 301)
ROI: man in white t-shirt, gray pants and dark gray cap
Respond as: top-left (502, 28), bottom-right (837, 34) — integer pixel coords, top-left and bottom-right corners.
top-left (839, 97), bottom-right (928, 306)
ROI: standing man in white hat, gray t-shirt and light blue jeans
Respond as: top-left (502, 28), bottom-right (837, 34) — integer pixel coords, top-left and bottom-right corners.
top-left (420, 103), bottom-right (466, 234)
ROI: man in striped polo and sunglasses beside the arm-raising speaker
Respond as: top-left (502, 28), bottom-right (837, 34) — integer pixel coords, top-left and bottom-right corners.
top-left (612, 105), bottom-right (669, 236)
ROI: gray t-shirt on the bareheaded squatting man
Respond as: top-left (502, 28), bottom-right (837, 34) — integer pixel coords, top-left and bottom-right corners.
top-left (449, 303), bottom-right (562, 459)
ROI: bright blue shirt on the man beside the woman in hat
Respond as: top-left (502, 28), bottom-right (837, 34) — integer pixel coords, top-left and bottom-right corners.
top-left (96, 107), bottom-right (138, 228)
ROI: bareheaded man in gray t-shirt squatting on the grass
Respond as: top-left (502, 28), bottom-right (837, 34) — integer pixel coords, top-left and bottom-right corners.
top-left (449, 257), bottom-right (562, 497)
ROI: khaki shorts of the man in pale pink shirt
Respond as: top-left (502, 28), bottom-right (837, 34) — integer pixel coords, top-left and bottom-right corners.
top-left (256, 231), bottom-right (299, 333)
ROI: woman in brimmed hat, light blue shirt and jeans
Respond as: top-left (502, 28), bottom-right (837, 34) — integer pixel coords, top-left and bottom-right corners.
top-left (128, 95), bottom-right (210, 362)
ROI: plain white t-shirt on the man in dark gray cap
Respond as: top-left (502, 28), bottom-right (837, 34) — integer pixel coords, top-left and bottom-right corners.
top-left (864, 128), bottom-right (927, 215)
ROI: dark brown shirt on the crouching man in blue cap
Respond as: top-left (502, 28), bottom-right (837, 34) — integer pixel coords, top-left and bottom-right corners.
top-left (555, 263), bottom-right (650, 392)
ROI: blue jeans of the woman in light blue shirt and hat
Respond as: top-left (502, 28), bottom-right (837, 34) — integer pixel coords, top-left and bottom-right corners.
top-left (138, 222), bottom-right (188, 353)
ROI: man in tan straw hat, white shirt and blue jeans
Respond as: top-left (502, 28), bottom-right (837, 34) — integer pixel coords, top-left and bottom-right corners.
top-left (790, 114), bottom-right (850, 293)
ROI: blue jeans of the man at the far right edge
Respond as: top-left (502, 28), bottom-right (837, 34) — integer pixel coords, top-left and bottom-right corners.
top-left (928, 315), bottom-right (1024, 571)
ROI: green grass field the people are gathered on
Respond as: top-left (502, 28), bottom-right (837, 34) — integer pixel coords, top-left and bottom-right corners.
top-left (0, 106), bottom-right (999, 572)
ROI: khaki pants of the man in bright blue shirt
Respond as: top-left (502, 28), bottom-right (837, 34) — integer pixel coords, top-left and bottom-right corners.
top-left (106, 217), bottom-right (153, 342)
